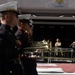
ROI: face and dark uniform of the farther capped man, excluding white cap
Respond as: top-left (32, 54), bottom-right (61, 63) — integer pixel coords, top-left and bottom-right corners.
top-left (15, 19), bottom-right (37, 75)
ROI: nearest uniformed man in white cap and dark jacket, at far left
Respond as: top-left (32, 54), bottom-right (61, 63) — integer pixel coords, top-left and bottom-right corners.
top-left (0, 1), bottom-right (23, 75)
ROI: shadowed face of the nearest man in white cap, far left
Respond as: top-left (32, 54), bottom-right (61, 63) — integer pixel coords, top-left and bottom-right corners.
top-left (3, 12), bottom-right (18, 27)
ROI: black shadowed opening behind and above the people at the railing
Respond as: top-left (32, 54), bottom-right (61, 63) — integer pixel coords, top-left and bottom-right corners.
top-left (33, 19), bottom-right (75, 48)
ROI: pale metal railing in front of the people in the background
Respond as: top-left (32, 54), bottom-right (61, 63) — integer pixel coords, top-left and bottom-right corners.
top-left (24, 47), bottom-right (75, 63)
